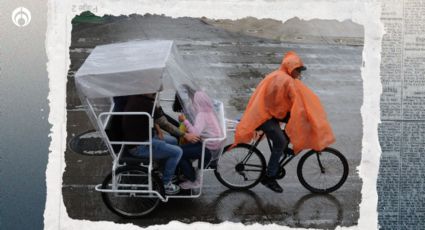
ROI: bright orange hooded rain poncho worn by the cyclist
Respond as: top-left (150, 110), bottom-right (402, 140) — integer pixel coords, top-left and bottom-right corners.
top-left (234, 51), bottom-right (335, 153)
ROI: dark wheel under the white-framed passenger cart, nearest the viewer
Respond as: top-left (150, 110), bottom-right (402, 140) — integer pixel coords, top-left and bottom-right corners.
top-left (102, 165), bottom-right (164, 218)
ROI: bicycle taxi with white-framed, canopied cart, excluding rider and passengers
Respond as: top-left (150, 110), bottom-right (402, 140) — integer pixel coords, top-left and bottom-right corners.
top-left (75, 40), bottom-right (348, 218)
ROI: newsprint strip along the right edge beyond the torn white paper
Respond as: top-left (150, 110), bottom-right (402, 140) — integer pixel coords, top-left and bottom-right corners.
top-left (378, 0), bottom-right (425, 229)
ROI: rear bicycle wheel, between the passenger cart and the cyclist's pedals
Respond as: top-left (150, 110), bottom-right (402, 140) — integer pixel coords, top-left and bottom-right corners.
top-left (214, 144), bottom-right (266, 190)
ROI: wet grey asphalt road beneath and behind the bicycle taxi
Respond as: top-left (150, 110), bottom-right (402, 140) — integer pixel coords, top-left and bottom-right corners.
top-left (62, 15), bottom-right (363, 228)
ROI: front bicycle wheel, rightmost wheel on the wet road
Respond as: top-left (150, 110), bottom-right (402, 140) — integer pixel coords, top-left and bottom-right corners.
top-left (297, 148), bottom-right (348, 194)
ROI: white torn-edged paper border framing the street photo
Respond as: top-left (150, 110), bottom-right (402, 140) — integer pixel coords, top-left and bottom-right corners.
top-left (44, 0), bottom-right (383, 230)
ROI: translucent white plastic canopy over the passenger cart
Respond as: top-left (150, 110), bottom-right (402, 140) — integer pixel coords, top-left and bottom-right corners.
top-left (75, 40), bottom-right (190, 98)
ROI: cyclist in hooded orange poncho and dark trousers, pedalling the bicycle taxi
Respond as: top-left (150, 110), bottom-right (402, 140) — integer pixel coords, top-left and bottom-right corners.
top-left (233, 51), bottom-right (335, 192)
